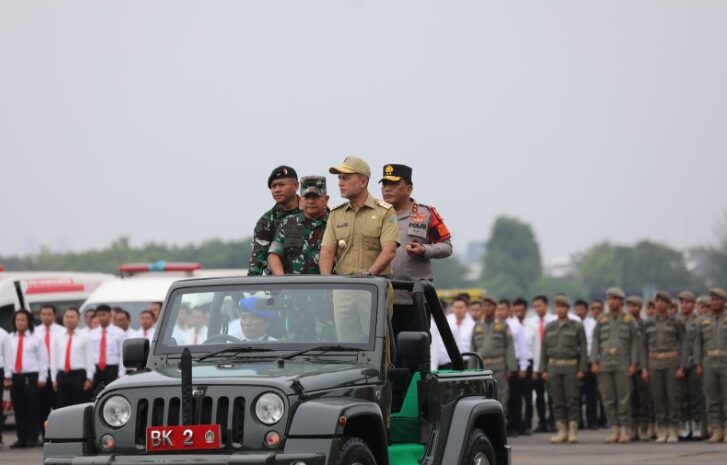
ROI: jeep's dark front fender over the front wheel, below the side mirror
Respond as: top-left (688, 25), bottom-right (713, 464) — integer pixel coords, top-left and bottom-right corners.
top-left (285, 397), bottom-right (389, 465)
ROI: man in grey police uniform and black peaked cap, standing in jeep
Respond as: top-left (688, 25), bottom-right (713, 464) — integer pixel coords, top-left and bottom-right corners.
top-left (379, 163), bottom-right (452, 333)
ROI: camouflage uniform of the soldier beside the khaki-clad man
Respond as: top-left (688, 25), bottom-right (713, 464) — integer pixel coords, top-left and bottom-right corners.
top-left (268, 212), bottom-right (328, 274)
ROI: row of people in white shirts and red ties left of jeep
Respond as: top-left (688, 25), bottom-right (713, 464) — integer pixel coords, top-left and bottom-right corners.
top-left (0, 305), bottom-right (155, 448)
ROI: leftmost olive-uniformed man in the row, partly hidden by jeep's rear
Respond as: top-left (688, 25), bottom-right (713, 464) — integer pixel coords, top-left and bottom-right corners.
top-left (472, 295), bottom-right (518, 418)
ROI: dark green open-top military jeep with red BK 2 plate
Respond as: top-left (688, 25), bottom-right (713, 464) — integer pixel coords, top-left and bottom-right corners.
top-left (44, 276), bottom-right (510, 465)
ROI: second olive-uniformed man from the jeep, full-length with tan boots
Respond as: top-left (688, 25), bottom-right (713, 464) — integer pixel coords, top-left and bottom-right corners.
top-left (540, 295), bottom-right (588, 444)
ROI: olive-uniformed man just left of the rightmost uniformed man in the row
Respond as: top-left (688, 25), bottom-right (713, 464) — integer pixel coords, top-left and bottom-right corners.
top-left (677, 291), bottom-right (705, 440)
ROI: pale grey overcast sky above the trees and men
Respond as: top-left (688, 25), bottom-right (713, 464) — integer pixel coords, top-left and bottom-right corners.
top-left (0, 0), bottom-right (727, 262)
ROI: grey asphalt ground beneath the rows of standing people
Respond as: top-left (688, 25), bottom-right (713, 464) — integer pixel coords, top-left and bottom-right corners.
top-left (0, 430), bottom-right (727, 465)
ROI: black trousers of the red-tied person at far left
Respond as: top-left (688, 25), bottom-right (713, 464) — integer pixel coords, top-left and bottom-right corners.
top-left (10, 372), bottom-right (40, 444)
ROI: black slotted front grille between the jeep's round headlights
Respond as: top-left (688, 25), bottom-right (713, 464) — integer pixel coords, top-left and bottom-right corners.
top-left (134, 396), bottom-right (245, 448)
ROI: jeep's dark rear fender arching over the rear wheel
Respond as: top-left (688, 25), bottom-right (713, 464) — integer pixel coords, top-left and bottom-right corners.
top-left (441, 396), bottom-right (508, 465)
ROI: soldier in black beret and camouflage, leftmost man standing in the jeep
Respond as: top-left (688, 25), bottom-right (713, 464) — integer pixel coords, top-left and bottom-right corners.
top-left (247, 165), bottom-right (300, 276)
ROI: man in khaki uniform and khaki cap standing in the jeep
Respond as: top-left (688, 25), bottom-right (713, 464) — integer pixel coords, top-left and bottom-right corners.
top-left (319, 157), bottom-right (399, 341)
